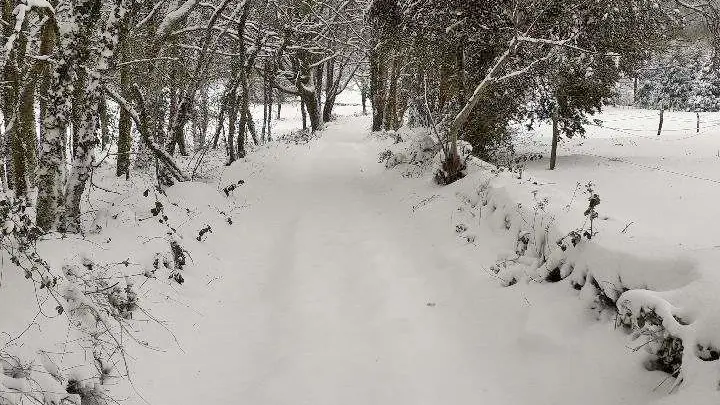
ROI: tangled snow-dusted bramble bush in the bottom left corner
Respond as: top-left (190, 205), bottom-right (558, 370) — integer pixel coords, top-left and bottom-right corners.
top-left (0, 191), bottom-right (150, 404)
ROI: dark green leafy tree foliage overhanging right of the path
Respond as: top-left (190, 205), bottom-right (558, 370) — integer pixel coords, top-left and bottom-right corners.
top-left (390, 0), bottom-right (681, 158)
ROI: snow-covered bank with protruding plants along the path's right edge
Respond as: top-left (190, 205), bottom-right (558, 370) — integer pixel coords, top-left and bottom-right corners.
top-left (385, 131), bottom-right (720, 400)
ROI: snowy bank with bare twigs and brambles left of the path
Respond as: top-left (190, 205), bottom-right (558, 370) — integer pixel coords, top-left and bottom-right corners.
top-left (0, 160), bottom-right (241, 405)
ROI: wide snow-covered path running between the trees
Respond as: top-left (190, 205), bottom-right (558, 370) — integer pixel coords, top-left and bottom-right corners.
top-left (135, 118), bottom-right (676, 405)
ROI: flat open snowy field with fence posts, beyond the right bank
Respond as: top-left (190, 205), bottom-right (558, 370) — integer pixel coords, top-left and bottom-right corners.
top-left (518, 107), bottom-right (720, 250)
